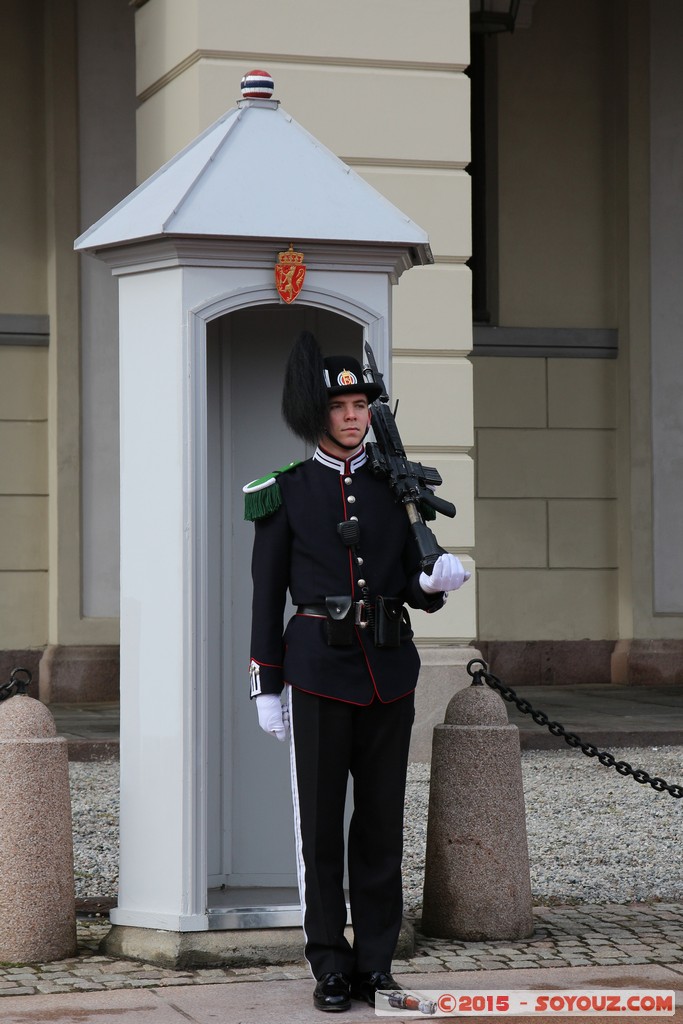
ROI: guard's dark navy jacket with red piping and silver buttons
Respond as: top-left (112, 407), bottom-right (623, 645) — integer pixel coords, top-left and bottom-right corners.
top-left (245, 447), bottom-right (443, 705)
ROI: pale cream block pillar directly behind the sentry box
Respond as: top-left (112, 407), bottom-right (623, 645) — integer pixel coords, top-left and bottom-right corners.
top-left (136, 0), bottom-right (476, 644)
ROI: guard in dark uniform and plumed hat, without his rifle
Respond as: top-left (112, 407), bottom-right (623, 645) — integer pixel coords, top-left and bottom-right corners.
top-left (245, 334), bottom-right (467, 1011)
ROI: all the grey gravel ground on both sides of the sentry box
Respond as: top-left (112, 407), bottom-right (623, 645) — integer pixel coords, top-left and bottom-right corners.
top-left (70, 746), bottom-right (683, 915)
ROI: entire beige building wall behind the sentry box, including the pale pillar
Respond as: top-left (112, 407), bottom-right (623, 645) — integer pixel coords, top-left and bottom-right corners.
top-left (6, 0), bottom-right (683, 671)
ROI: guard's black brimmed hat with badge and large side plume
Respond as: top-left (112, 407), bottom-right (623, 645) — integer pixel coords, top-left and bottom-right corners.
top-left (283, 331), bottom-right (382, 444)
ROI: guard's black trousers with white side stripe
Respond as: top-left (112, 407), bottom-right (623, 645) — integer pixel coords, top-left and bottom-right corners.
top-left (290, 689), bottom-right (415, 978)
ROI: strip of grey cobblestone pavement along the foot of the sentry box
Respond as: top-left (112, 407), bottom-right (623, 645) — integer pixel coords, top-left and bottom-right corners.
top-left (0, 903), bottom-right (683, 995)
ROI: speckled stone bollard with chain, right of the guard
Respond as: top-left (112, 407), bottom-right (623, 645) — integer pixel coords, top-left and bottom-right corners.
top-left (422, 684), bottom-right (533, 942)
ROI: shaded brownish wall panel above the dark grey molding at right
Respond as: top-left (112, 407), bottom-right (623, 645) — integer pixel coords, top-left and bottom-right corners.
top-left (498, 0), bottom-right (618, 328)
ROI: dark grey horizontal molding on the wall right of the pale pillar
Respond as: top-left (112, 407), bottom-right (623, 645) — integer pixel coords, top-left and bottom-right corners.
top-left (471, 324), bottom-right (618, 359)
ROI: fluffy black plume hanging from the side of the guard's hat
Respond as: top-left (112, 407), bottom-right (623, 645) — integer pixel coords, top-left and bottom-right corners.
top-left (283, 331), bottom-right (328, 444)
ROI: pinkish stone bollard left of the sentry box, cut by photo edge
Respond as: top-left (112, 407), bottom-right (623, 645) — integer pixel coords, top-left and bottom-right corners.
top-left (0, 694), bottom-right (77, 964)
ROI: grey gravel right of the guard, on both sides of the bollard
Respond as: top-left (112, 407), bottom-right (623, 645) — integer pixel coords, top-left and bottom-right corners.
top-left (403, 746), bottom-right (683, 914)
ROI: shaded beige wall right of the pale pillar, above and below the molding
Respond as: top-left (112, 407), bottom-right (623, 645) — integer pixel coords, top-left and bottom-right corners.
top-left (474, 0), bottom-right (683, 640)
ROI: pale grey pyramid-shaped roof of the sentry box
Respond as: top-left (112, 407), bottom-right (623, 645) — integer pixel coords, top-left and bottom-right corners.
top-left (75, 79), bottom-right (432, 265)
